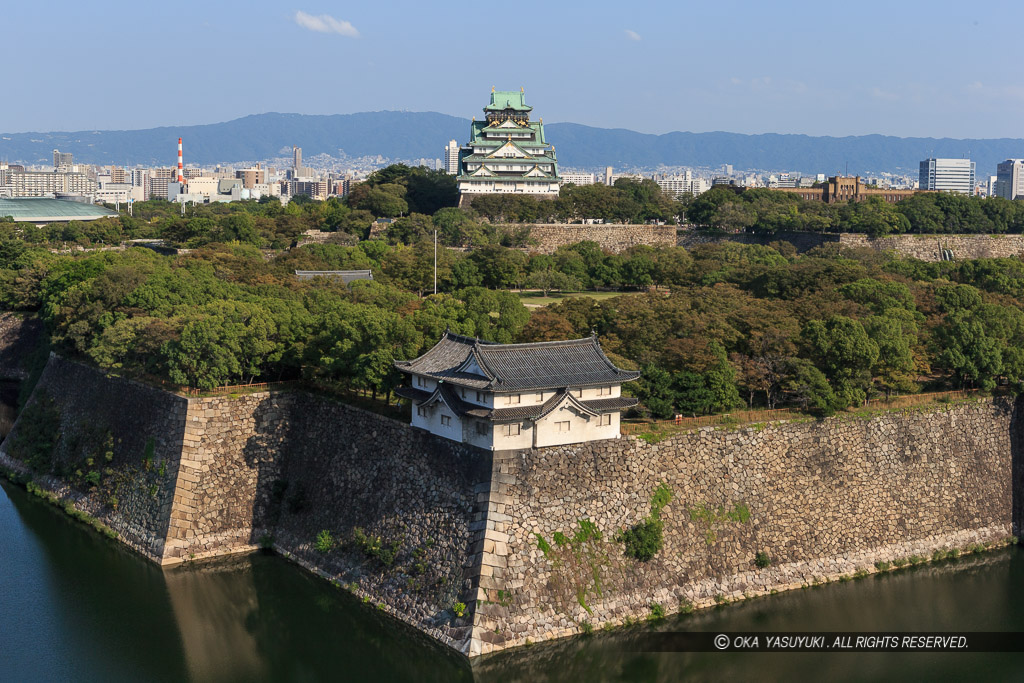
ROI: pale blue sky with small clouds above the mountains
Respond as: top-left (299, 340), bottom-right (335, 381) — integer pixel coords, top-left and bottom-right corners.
top-left (8, 0), bottom-right (1024, 137)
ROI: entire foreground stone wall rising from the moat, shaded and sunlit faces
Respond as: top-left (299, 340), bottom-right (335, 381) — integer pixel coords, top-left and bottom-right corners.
top-left (0, 355), bottom-right (1024, 655)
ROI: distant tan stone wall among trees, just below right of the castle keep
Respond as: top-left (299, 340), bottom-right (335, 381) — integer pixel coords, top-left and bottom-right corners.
top-left (499, 223), bottom-right (676, 254)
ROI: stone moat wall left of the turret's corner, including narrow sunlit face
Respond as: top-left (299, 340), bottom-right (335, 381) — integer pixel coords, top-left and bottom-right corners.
top-left (0, 354), bottom-right (492, 651)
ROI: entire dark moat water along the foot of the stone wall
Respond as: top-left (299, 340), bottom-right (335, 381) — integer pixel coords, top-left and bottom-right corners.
top-left (0, 482), bottom-right (1024, 682)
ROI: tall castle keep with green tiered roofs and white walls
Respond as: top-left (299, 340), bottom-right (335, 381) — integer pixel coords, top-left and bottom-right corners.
top-left (457, 88), bottom-right (559, 204)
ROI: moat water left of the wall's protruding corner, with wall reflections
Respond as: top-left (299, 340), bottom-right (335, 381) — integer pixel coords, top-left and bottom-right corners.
top-left (0, 483), bottom-right (472, 681)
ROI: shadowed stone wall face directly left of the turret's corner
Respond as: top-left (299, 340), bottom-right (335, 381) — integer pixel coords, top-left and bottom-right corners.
top-left (244, 392), bottom-right (490, 651)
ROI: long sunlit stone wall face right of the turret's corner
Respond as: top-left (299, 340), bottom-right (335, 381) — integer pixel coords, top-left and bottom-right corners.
top-left (476, 399), bottom-right (1016, 652)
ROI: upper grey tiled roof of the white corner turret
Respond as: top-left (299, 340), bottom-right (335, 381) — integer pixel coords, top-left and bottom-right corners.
top-left (395, 332), bottom-right (640, 392)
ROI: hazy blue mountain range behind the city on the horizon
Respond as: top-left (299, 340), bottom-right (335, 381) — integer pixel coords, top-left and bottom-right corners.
top-left (0, 112), bottom-right (1024, 177)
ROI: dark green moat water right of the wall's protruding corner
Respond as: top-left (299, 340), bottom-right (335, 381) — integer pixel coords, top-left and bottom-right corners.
top-left (474, 548), bottom-right (1024, 683)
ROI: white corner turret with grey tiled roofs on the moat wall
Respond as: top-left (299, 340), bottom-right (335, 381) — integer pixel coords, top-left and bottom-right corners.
top-left (394, 332), bottom-right (640, 451)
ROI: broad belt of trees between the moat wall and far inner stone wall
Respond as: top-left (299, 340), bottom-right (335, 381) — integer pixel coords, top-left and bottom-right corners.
top-left (0, 227), bottom-right (1024, 417)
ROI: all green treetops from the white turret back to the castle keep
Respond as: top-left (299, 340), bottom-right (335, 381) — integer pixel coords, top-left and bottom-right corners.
top-left (6, 166), bottom-right (1024, 417)
